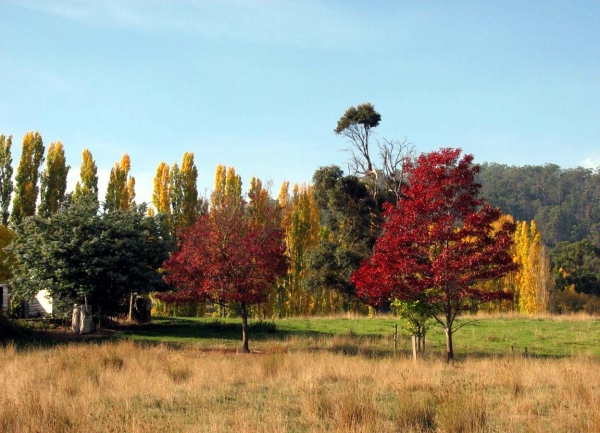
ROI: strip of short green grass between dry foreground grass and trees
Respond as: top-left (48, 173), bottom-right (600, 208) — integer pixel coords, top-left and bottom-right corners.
top-left (117, 315), bottom-right (600, 359)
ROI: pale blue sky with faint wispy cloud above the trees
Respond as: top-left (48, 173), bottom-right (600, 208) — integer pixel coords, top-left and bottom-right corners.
top-left (0, 0), bottom-right (600, 202)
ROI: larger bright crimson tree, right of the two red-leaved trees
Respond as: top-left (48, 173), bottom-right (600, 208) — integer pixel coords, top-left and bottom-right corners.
top-left (352, 149), bottom-right (517, 360)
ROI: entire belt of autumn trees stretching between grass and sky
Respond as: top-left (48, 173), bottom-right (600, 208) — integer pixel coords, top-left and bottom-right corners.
top-left (0, 104), bottom-right (597, 357)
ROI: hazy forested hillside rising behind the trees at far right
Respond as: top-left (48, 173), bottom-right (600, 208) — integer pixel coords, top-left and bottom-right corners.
top-left (478, 163), bottom-right (600, 247)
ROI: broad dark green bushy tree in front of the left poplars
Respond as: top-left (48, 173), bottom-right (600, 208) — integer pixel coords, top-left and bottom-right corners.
top-left (12, 196), bottom-right (171, 311)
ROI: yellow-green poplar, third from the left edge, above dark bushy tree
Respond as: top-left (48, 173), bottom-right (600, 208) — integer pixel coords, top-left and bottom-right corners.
top-left (38, 141), bottom-right (71, 217)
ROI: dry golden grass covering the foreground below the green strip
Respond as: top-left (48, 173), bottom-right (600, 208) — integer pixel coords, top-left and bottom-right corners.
top-left (0, 337), bottom-right (600, 433)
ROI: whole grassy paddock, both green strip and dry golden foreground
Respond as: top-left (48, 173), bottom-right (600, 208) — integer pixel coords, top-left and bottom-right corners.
top-left (0, 315), bottom-right (600, 432)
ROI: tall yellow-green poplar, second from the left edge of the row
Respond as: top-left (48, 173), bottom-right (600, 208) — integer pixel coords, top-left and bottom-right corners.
top-left (12, 131), bottom-right (44, 225)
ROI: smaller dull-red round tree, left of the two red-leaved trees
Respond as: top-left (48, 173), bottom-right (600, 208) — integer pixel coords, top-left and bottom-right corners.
top-left (160, 196), bottom-right (287, 352)
